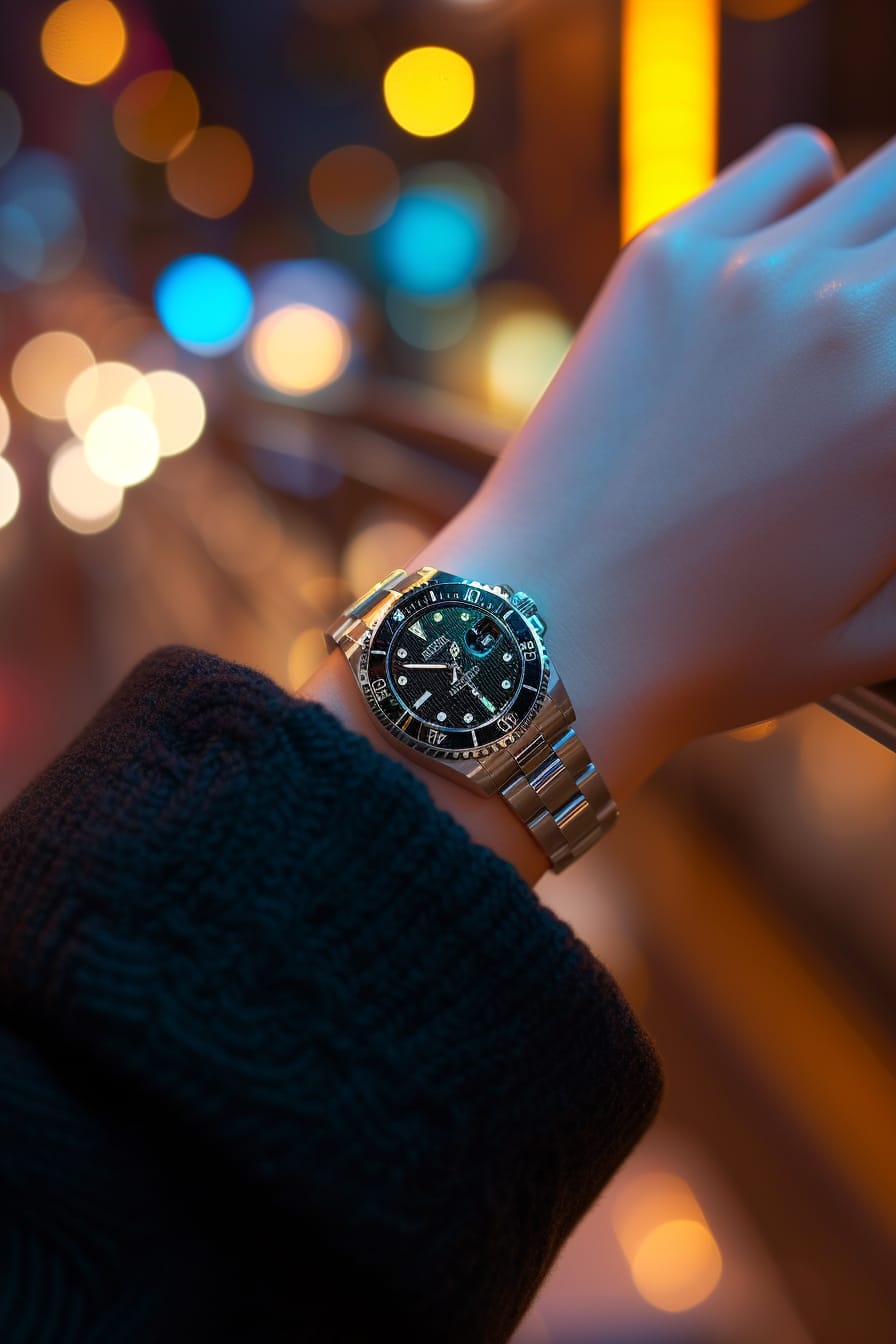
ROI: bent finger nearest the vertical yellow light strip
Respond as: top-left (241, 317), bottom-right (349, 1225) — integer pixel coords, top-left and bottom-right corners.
top-left (685, 122), bottom-right (844, 237)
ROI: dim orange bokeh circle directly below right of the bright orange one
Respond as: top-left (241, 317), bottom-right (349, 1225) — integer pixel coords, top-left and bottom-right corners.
top-left (113, 70), bottom-right (199, 164)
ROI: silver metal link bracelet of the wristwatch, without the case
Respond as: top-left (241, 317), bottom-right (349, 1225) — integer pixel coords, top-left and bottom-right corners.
top-left (325, 567), bottom-right (619, 872)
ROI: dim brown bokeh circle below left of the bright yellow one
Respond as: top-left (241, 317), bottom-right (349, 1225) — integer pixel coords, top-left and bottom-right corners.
top-left (309, 145), bottom-right (399, 235)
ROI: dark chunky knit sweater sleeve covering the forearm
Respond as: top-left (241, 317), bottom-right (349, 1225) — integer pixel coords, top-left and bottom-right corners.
top-left (0, 648), bottom-right (661, 1344)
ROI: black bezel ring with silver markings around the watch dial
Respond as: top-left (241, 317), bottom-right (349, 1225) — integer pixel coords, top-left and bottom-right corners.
top-left (356, 575), bottom-right (551, 761)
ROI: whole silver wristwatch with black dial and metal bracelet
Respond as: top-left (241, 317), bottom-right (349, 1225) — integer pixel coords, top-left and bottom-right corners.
top-left (325, 567), bottom-right (618, 872)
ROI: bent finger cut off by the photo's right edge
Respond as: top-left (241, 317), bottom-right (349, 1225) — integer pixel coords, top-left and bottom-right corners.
top-left (779, 137), bottom-right (896, 247)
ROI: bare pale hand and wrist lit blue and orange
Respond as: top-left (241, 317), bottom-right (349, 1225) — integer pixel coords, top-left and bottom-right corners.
top-left (300, 125), bottom-right (896, 884)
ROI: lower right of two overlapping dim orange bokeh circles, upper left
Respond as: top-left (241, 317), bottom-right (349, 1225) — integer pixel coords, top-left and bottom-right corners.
top-left (165, 126), bottom-right (254, 219)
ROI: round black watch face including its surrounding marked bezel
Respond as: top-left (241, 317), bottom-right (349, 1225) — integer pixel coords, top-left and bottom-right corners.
top-left (359, 581), bottom-right (548, 759)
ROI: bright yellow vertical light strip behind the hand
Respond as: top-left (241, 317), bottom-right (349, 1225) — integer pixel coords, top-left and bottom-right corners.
top-left (621, 0), bottom-right (719, 243)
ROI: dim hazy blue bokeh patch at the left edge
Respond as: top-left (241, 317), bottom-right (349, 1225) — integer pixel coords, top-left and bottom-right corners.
top-left (0, 149), bottom-right (86, 290)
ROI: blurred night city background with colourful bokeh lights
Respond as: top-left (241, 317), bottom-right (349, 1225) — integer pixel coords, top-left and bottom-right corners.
top-left (0, 0), bottom-right (896, 1344)
